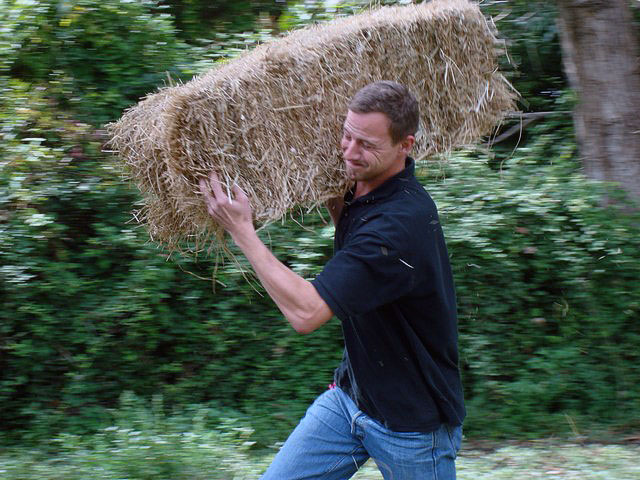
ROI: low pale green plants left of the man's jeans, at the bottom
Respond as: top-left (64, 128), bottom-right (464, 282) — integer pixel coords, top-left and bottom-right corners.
top-left (0, 392), bottom-right (265, 480)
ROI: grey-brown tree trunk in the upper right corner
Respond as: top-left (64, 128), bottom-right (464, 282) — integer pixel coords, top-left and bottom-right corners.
top-left (557, 0), bottom-right (640, 200)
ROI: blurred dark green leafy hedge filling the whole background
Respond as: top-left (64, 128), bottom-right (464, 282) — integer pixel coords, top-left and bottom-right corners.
top-left (0, 0), bottom-right (640, 468)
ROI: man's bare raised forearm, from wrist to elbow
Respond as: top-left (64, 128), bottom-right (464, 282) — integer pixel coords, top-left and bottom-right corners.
top-left (233, 230), bottom-right (332, 333)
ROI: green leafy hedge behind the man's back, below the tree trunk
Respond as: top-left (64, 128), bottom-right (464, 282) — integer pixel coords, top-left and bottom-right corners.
top-left (420, 144), bottom-right (640, 436)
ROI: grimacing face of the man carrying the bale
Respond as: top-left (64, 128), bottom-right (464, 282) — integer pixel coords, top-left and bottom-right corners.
top-left (340, 110), bottom-right (413, 187)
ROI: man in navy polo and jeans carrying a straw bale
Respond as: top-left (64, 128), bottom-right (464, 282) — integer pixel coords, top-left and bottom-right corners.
top-left (200, 81), bottom-right (465, 480)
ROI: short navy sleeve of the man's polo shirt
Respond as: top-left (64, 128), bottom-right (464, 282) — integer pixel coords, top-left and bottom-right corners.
top-left (312, 222), bottom-right (418, 319)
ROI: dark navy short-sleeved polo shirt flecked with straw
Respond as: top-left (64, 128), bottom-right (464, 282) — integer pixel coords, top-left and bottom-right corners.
top-left (312, 159), bottom-right (465, 432)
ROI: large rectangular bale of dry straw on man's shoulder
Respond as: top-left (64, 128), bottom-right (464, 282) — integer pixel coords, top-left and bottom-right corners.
top-left (110, 0), bottom-right (516, 255)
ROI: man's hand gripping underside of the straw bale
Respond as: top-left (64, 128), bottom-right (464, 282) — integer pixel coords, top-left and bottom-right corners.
top-left (200, 172), bottom-right (253, 241)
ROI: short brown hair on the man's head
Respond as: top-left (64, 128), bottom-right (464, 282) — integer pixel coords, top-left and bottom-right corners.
top-left (349, 80), bottom-right (420, 145)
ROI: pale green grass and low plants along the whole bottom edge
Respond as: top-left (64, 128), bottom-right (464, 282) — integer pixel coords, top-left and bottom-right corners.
top-left (0, 395), bottom-right (640, 480)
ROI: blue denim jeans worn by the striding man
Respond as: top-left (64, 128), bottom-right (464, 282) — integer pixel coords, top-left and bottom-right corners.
top-left (261, 388), bottom-right (462, 480)
